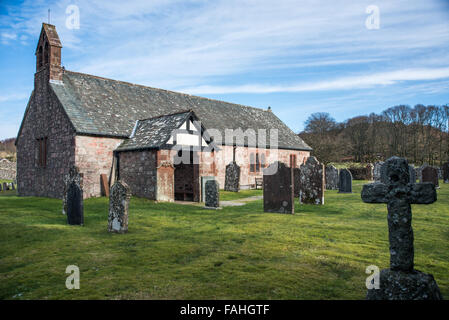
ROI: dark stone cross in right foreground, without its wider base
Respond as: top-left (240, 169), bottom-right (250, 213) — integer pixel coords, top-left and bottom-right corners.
top-left (362, 157), bottom-right (437, 271)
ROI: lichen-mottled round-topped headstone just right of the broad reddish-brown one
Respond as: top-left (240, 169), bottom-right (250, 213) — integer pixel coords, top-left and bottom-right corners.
top-left (299, 157), bottom-right (324, 204)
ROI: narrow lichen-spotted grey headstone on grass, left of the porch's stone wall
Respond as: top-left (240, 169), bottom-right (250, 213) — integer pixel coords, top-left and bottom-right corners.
top-left (108, 180), bottom-right (131, 233)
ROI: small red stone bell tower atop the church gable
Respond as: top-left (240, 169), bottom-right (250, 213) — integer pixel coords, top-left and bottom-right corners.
top-left (36, 23), bottom-right (62, 81)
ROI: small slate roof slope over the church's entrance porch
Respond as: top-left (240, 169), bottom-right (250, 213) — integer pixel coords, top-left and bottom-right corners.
top-left (116, 111), bottom-right (191, 151)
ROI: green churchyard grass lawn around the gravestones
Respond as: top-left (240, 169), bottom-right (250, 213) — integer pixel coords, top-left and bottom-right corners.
top-left (0, 181), bottom-right (449, 299)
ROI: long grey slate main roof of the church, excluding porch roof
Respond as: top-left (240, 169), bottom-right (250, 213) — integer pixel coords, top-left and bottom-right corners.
top-left (50, 70), bottom-right (311, 150)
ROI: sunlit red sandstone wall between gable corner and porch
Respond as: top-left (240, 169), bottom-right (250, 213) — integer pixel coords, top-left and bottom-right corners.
top-left (75, 136), bottom-right (123, 198)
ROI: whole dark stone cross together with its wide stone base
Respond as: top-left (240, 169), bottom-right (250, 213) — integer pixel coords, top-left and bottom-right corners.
top-left (361, 157), bottom-right (442, 300)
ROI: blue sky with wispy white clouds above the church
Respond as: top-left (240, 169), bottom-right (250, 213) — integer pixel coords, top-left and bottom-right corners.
top-left (0, 0), bottom-right (449, 139)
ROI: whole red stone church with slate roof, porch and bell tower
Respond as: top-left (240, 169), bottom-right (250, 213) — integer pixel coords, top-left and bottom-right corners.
top-left (16, 23), bottom-right (311, 201)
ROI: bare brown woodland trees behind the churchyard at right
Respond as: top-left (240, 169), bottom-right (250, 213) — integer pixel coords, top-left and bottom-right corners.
top-left (298, 104), bottom-right (449, 166)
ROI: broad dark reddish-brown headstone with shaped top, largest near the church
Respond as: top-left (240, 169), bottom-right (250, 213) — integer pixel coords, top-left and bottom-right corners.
top-left (263, 161), bottom-right (295, 214)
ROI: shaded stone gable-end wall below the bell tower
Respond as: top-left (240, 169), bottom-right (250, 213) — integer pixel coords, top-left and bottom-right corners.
top-left (17, 68), bottom-right (75, 198)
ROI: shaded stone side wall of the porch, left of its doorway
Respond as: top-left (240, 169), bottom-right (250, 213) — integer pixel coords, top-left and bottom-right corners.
top-left (118, 150), bottom-right (157, 200)
